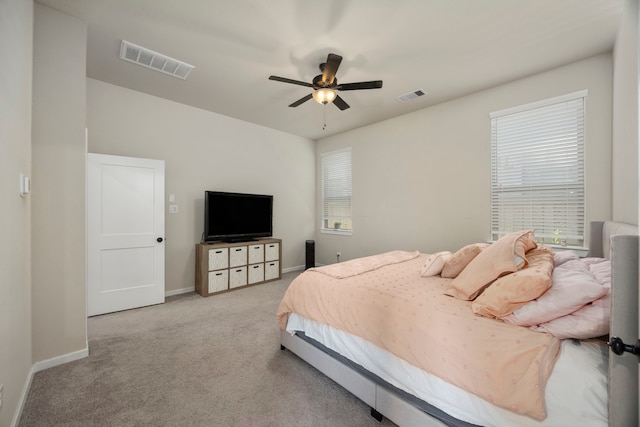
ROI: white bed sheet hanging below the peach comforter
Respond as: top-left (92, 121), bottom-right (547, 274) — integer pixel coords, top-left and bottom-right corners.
top-left (287, 313), bottom-right (608, 427)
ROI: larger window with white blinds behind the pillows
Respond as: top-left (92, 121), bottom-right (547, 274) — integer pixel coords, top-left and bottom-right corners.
top-left (490, 90), bottom-right (587, 247)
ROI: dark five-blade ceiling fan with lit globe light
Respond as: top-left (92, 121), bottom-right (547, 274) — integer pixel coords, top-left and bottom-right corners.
top-left (269, 53), bottom-right (382, 110)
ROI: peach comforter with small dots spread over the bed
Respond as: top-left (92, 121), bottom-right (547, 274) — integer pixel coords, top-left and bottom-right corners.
top-left (277, 251), bottom-right (560, 419)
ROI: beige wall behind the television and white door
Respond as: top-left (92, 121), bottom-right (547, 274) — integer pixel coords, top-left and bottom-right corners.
top-left (87, 78), bottom-right (315, 292)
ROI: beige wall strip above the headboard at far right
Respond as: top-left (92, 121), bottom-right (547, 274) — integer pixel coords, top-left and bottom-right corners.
top-left (612, 0), bottom-right (640, 224)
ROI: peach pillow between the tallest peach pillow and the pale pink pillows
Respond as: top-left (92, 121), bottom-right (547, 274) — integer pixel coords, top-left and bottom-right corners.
top-left (471, 246), bottom-right (553, 317)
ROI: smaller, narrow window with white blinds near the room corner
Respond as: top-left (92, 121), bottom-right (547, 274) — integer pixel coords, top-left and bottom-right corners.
top-left (321, 148), bottom-right (352, 234)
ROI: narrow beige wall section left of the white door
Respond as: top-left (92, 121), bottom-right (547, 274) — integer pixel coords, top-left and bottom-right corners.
top-left (31, 4), bottom-right (87, 362)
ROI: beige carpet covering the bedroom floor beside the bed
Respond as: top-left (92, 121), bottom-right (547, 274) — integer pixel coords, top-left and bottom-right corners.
top-left (19, 273), bottom-right (394, 427)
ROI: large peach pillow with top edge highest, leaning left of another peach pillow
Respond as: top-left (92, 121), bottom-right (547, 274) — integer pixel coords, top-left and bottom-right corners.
top-left (445, 230), bottom-right (537, 301)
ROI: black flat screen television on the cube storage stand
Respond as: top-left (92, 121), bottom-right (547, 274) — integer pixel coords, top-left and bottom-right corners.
top-left (203, 191), bottom-right (273, 242)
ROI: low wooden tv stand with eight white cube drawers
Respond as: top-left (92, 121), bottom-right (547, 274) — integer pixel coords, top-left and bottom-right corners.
top-left (196, 238), bottom-right (282, 297)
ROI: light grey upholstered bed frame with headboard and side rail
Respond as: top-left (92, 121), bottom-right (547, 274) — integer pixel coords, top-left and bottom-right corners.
top-left (280, 221), bottom-right (640, 427)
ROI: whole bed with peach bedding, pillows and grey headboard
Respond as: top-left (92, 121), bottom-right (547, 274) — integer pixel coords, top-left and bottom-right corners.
top-left (277, 221), bottom-right (638, 426)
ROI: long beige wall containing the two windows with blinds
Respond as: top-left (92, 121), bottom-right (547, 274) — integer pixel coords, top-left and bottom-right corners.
top-left (316, 54), bottom-right (616, 264)
